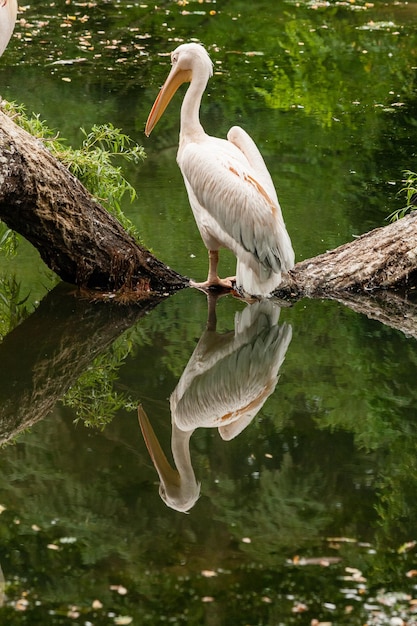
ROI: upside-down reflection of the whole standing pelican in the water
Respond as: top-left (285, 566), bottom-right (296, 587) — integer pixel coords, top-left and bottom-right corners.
top-left (139, 300), bottom-right (292, 512)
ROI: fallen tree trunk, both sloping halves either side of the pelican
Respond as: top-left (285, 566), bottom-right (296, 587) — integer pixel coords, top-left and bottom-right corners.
top-left (0, 105), bottom-right (417, 300)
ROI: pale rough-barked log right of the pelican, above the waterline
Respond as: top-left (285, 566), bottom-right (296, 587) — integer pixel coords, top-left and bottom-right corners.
top-left (276, 211), bottom-right (417, 298)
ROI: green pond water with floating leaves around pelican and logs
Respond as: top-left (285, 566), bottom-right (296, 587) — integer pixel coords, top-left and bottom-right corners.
top-left (0, 1), bottom-right (417, 626)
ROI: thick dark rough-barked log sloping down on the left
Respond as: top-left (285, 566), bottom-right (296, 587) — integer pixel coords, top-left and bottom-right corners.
top-left (0, 111), bottom-right (187, 293)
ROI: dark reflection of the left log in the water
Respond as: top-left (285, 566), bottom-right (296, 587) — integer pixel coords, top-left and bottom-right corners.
top-left (0, 283), bottom-right (164, 444)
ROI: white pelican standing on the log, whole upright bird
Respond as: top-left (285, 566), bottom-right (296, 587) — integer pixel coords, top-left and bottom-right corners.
top-left (145, 43), bottom-right (294, 297)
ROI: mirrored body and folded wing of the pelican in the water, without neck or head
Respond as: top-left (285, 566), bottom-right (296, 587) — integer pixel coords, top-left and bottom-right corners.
top-left (170, 301), bottom-right (291, 432)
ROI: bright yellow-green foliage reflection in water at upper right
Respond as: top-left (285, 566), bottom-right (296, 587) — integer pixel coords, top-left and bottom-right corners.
top-left (255, 8), bottom-right (413, 126)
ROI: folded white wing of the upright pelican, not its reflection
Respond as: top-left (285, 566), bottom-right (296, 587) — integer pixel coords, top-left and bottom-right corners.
top-left (179, 137), bottom-right (294, 272)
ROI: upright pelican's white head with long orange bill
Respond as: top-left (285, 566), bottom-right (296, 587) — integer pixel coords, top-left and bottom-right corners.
top-left (145, 43), bottom-right (213, 137)
